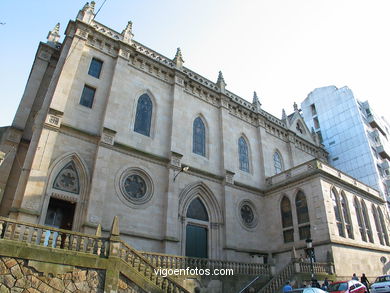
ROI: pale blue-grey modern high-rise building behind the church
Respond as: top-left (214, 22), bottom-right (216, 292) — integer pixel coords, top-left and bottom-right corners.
top-left (301, 86), bottom-right (390, 201)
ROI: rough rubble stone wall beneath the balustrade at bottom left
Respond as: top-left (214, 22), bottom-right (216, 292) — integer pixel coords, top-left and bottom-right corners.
top-left (0, 256), bottom-right (105, 293)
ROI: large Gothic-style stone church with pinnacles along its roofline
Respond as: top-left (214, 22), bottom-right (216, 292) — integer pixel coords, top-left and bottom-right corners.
top-left (0, 2), bottom-right (390, 278)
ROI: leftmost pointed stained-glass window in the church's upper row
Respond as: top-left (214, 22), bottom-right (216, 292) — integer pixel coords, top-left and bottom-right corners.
top-left (134, 94), bottom-right (153, 136)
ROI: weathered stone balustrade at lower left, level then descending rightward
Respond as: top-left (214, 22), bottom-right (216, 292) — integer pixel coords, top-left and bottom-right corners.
top-left (0, 217), bottom-right (190, 293)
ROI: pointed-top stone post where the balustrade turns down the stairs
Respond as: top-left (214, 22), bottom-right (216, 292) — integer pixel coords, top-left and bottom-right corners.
top-left (104, 216), bottom-right (121, 292)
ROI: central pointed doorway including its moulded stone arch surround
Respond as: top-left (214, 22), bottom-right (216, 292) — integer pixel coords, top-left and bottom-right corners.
top-left (179, 182), bottom-right (223, 259)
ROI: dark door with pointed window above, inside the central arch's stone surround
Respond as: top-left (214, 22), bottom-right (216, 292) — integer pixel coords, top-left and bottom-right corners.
top-left (185, 197), bottom-right (209, 258)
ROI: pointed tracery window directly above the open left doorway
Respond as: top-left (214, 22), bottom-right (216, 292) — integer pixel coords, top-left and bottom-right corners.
top-left (53, 161), bottom-right (80, 194)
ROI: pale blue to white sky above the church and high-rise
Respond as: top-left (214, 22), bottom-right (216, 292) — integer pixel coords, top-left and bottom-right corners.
top-left (0, 0), bottom-right (390, 126)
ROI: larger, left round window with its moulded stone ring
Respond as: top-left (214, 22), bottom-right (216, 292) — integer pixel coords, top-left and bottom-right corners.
top-left (119, 168), bottom-right (153, 205)
